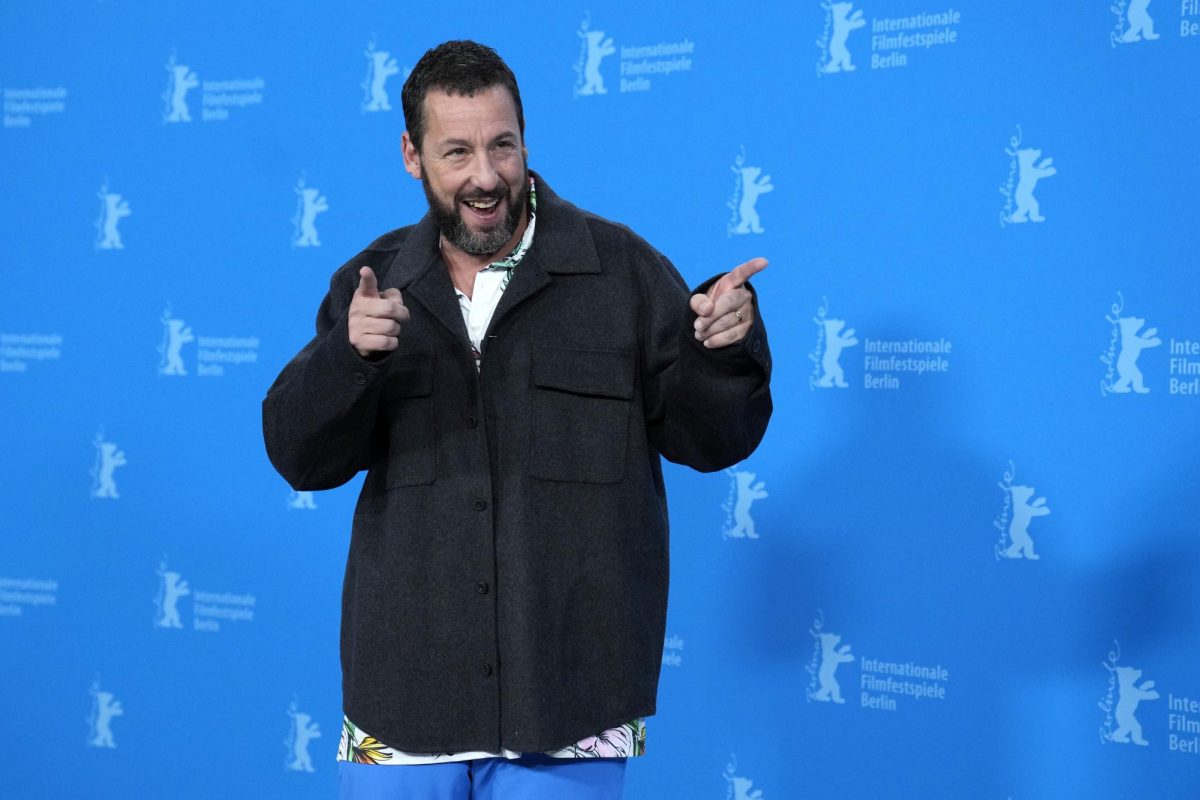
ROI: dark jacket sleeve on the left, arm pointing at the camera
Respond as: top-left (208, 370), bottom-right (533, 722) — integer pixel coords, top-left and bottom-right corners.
top-left (263, 260), bottom-right (388, 491)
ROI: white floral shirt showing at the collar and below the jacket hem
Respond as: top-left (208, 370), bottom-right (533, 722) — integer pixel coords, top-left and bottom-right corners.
top-left (337, 178), bottom-right (646, 765)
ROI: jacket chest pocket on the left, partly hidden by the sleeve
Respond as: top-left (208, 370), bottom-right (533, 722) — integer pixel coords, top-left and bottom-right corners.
top-left (379, 354), bottom-right (437, 489)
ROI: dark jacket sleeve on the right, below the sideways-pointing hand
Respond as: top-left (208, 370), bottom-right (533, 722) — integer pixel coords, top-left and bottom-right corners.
top-left (642, 254), bottom-right (772, 473)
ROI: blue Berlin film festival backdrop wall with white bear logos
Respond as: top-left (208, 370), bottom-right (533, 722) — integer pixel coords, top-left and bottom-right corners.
top-left (0, 0), bottom-right (1200, 800)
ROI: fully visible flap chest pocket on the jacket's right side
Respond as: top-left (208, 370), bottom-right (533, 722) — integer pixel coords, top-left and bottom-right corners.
top-left (529, 348), bottom-right (634, 483)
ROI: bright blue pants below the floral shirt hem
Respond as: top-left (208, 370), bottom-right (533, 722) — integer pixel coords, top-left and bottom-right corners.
top-left (338, 754), bottom-right (625, 800)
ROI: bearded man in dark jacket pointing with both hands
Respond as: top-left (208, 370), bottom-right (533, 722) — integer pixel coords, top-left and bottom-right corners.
top-left (263, 42), bottom-right (772, 800)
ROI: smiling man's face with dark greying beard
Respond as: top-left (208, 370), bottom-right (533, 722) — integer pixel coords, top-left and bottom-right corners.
top-left (403, 86), bottom-right (529, 255)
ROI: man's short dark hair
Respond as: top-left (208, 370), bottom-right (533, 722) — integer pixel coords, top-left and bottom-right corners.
top-left (400, 40), bottom-right (524, 150)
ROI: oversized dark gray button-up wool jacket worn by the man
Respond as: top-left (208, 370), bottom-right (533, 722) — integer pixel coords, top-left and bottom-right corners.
top-left (263, 178), bottom-right (772, 753)
